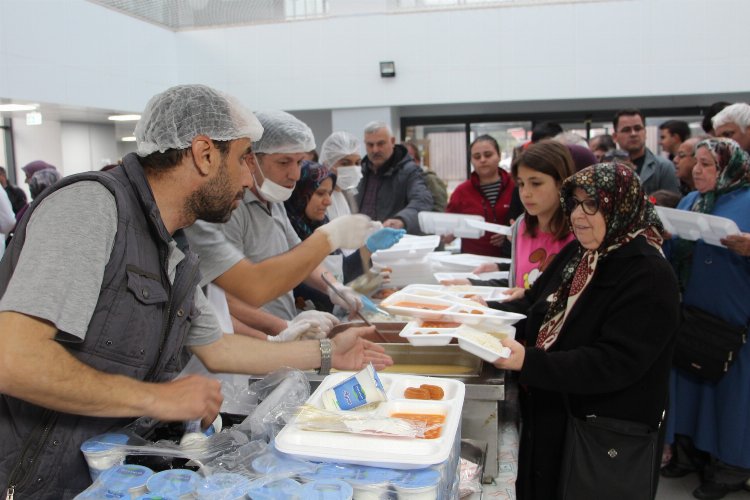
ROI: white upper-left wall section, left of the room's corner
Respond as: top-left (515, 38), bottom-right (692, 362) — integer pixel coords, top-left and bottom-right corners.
top-left (0, 0), bottom-right (180, 111)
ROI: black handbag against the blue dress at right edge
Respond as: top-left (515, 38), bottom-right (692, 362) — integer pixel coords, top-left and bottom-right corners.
top-left (673, 306), bottom-right (747, 382)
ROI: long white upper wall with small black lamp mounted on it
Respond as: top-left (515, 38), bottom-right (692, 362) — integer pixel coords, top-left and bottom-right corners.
top-left (176, 0), bottom-right (750, 110)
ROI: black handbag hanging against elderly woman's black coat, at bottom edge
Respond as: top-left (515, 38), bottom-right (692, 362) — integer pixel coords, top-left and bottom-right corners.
top-left (560, 395), bottom-right (664, 500)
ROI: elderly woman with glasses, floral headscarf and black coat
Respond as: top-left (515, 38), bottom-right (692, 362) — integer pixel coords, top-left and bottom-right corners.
top-left (495, 163), bottom-right (679, 500)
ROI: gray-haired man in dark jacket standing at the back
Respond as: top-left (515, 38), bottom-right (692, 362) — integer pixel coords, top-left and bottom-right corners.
top-left (357, 122), bottom-right (433, 234)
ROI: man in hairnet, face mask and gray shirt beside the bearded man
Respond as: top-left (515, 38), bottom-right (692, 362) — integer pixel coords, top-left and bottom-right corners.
top-left (217, 111), bottom-right (370, 331)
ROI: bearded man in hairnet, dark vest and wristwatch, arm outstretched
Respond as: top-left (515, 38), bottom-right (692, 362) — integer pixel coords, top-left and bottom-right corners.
top-left (0, 85), bottom-right (390, 499)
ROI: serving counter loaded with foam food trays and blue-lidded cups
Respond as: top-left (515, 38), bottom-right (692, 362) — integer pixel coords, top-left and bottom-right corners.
top-left (72, 229), bottom-right (523, 500)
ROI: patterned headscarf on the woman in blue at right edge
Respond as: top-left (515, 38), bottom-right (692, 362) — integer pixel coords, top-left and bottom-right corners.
top-left (672, 137), bottom-right (750, 290)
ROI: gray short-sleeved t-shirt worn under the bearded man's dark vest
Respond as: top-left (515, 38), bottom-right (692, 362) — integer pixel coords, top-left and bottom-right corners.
top-left (0, 181), bottom-right (223, 345)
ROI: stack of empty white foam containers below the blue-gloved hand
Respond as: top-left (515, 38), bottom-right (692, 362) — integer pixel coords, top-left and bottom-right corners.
top-left (372, 235), bottom-right (440, 287)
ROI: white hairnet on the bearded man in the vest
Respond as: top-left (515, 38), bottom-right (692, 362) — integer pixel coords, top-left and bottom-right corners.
top-left (135, 85), bottom-right (263, 156)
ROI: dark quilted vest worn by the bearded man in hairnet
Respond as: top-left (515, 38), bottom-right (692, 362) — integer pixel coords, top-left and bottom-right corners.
top-left (0, 154), bottom-right (199, 499)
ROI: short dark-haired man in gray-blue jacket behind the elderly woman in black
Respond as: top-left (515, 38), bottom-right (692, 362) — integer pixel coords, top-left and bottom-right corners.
top-left (612, 109), bottom-right (680, 194)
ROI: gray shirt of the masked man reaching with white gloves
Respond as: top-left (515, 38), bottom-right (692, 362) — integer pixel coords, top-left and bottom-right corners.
top-left (222, 189), bottom-right (300, 320)
